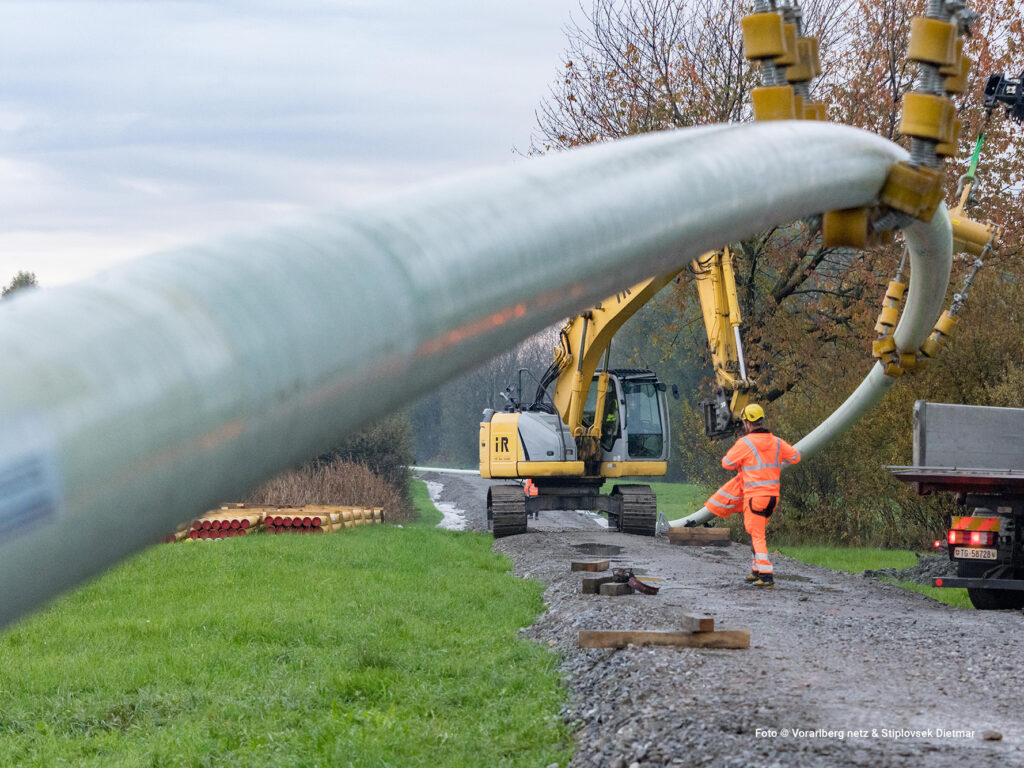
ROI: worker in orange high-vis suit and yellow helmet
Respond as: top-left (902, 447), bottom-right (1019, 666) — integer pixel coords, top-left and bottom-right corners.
top-left (705, 403), bottom-right (800, 589)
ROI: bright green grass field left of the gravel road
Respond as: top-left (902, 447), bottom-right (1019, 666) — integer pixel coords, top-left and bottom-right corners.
top-left (0, 483), bottom-right (572, 767)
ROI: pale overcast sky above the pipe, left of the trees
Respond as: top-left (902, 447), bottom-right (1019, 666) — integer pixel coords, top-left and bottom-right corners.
top-left (0, 0), bottom-right (581, 285)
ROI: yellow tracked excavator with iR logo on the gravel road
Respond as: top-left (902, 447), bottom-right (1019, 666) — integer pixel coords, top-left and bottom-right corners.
top-left (479, 249), bottom-right (755, 537)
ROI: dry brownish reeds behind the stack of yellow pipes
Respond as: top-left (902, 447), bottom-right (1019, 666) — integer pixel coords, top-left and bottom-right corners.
top-left (246, 461), bottom-right (410, 522)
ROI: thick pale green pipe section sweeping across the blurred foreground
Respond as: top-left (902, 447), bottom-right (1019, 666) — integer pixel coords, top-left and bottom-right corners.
top-left (0, 122), bottom-right (933, 624)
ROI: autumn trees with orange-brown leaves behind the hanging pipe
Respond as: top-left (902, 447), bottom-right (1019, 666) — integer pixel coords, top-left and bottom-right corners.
top-left (534, 0), bottom-right (1024, 541)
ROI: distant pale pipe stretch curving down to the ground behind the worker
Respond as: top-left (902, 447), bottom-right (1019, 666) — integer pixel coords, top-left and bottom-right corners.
top-left (669, 204), bottom-right (953, 527)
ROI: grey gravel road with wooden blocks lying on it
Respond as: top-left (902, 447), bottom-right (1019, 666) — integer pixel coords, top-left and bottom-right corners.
top-left (419, 474), bottom-right (1024, 768)
